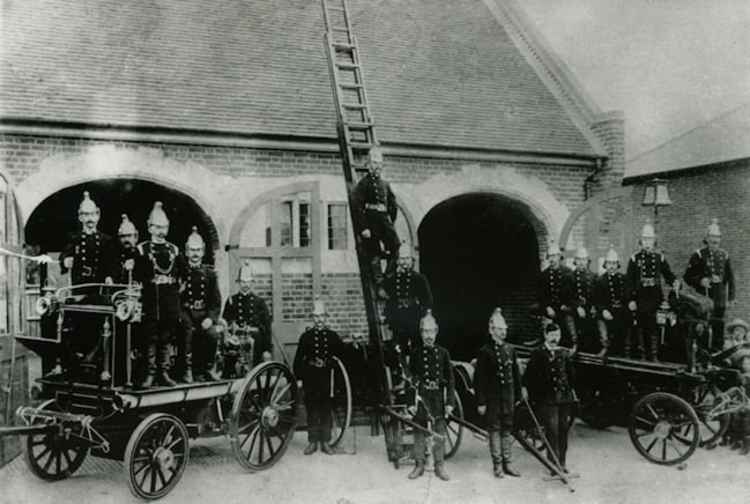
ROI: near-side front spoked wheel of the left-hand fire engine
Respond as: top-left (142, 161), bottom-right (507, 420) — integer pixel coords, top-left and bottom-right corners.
top-left (125, 413), bottom-right (190, 500)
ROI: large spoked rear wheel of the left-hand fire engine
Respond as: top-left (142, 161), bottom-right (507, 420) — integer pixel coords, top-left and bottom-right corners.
top-left (229, 362), bottom-right (298, 471)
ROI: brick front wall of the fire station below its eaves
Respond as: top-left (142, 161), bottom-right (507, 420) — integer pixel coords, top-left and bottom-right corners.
top-left (0, 131), bottom-right (596, 346)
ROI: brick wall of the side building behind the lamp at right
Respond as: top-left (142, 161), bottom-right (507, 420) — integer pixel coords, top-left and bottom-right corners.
top-left (633, 159), bottom-right (750, 320)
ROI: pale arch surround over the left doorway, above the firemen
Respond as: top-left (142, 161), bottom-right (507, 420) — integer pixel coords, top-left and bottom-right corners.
top-left (15, 145), bottom-right (227, 247)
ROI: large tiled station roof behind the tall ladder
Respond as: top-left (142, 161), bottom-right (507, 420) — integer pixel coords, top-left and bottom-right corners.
top-left (0, 0), bottom-right (595, 155)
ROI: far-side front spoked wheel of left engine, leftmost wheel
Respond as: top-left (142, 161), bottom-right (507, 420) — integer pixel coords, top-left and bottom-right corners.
top-left (24, 399), bottom-right (89, 481)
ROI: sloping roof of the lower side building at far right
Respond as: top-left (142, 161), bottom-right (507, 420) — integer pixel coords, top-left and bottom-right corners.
top-left (625, 103), bottom-right (750, 178)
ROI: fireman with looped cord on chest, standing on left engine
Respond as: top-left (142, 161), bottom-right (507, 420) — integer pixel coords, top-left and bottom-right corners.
top-left (138, 201), bottom-right (187, 388)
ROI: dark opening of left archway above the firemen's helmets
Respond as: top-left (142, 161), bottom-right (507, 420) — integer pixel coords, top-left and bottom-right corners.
top-left (25, 178), bottom-right (219, 263)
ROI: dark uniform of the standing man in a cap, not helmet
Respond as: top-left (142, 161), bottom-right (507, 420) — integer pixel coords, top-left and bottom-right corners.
top-left (523, 344), bottom-right (575, 466)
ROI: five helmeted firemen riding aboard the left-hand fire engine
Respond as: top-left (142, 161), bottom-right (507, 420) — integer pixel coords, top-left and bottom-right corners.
top-left (49, 191), bottom-right (271, 388)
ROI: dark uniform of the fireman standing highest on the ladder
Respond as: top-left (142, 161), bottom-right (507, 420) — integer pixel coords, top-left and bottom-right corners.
top-left (352, 173), bottom-right (399, 264)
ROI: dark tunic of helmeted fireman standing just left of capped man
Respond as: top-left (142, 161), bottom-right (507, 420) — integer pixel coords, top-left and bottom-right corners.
top-left (474, 340), bottom-right (521, 432)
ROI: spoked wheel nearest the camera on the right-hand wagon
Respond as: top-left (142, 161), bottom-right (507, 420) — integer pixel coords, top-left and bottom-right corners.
top-left (628, 392), bottom-right (701, 465)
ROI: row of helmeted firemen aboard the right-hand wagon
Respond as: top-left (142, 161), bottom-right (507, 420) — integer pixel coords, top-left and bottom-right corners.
top-left (536, 219), bottom-right (735, 361)
